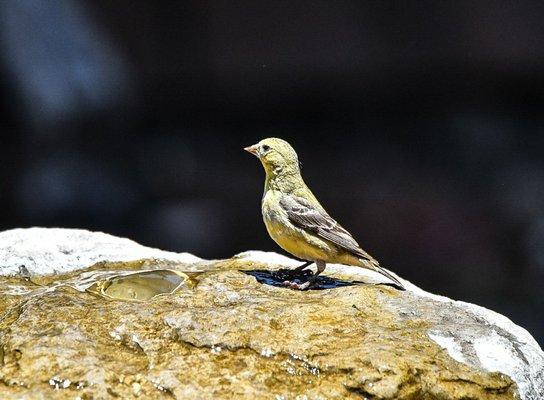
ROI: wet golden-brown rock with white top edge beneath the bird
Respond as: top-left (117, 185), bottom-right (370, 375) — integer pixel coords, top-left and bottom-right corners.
top-left (0, 228), bottom-right (544, 400)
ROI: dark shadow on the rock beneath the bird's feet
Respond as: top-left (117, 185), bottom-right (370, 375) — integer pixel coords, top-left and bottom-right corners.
top-left (242, 269), bottom-right (355, 290)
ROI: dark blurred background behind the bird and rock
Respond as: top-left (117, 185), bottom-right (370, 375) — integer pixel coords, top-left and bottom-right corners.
top-left (0, 0), bottom-right (544, 344)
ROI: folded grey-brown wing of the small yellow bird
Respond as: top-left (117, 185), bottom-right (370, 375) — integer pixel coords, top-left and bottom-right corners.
top-left (280, 194), bottom-right (378, 265)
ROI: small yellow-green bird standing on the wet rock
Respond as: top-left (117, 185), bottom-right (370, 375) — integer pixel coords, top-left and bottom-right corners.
top-left (244, 138), bottom-right (405, 290)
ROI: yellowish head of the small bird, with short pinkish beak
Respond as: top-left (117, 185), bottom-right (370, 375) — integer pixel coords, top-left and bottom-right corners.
top-left (244, 138), bottom-right (300, 176)
